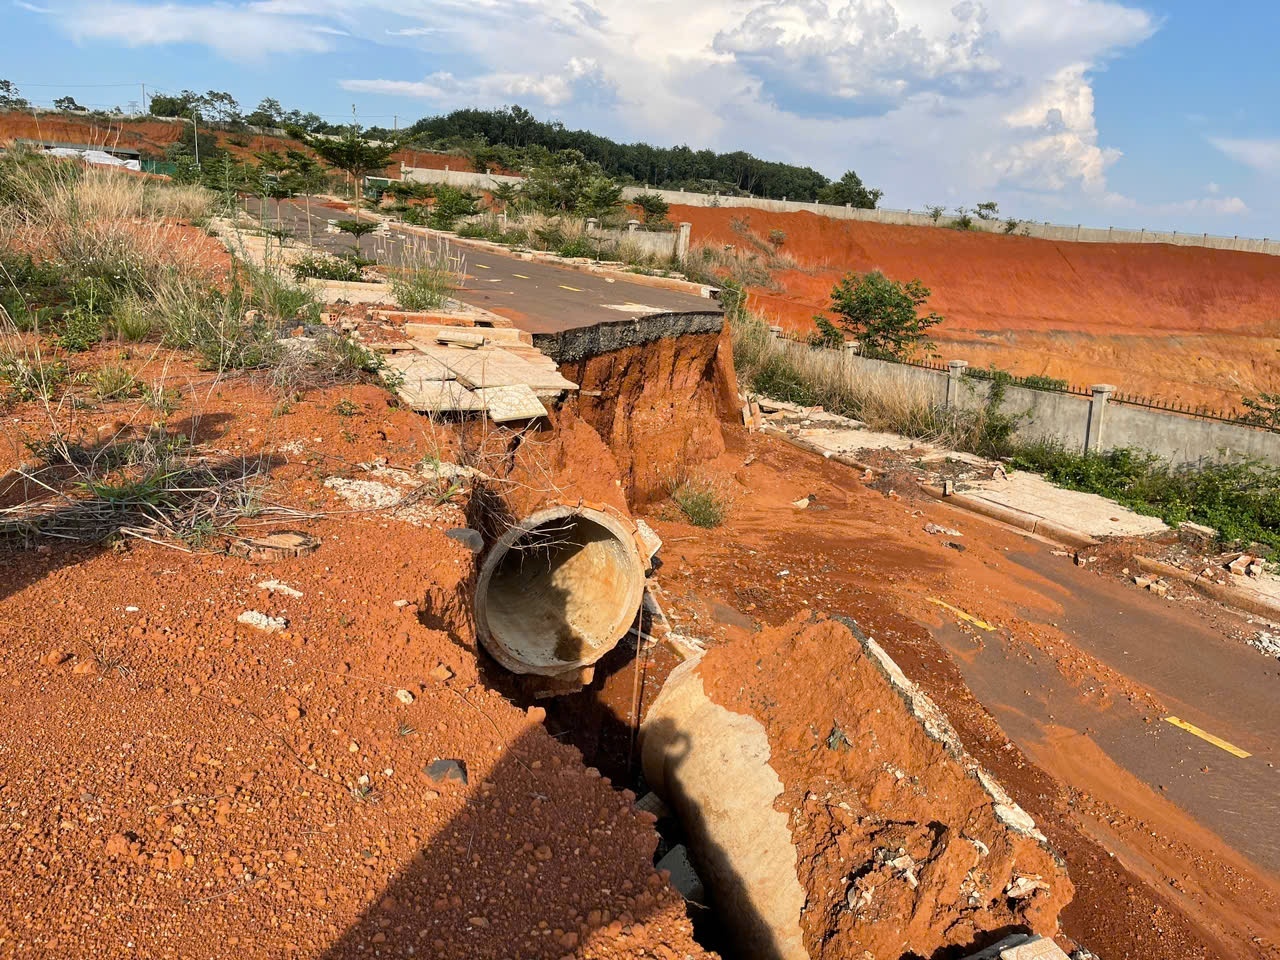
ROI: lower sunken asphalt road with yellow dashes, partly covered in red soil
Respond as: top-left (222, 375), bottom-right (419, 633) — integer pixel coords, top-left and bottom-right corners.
top-left (934, 549), bottom-right (1280, 872)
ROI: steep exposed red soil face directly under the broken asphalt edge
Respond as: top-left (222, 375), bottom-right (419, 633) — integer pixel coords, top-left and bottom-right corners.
top-left (561, 326), bottom-right (737, 506)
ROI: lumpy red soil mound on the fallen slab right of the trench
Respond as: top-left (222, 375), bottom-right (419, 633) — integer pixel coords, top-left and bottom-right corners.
top-left (699, 614), bottom-right (1073, 960)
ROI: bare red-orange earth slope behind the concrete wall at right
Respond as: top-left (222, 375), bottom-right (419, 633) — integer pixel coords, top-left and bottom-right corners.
top-left (669, 206), bottom-right (1280, 407)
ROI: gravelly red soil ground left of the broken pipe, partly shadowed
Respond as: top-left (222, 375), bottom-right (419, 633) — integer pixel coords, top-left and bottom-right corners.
top-left (0, 346), bottom-right (704, 960)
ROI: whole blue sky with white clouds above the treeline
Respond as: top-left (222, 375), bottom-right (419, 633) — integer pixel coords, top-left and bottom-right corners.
top-left (0, 0), bottom-right (1280, 237)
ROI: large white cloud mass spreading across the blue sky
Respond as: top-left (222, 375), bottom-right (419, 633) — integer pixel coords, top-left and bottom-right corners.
top-left (40, 0), bottom-right (1192, 216)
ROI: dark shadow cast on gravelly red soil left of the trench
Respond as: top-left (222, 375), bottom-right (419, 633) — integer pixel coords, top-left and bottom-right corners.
top-left (314, 730), bottom-right (701, 960)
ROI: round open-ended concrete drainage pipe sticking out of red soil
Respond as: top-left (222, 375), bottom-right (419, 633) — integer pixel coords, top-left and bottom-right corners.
top-left (475, 506), bottom-right (645, 676)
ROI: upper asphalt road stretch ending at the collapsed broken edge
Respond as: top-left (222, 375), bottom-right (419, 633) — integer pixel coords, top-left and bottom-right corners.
top-left (241, 200), bottom-right (721, 333)
